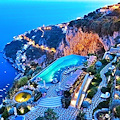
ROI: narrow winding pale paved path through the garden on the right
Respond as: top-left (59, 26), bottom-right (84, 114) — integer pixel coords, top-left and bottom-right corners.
top-left (83, 58), bottom-right (116, 120)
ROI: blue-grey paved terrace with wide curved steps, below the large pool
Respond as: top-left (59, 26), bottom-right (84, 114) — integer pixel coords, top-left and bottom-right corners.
top-left (25, 66), bottom-right (83, 120)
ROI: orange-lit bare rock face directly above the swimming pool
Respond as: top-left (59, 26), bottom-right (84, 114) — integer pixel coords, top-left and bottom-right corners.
top-left (63, 27), bottom-right (104, 56)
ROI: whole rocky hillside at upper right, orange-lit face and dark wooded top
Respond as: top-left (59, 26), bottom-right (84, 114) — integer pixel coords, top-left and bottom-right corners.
top-left (60, 4), bottom-right (120, 55)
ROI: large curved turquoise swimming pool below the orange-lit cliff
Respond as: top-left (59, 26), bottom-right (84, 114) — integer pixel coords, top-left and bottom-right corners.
top-left (35, 55), bottom-right (86, 83)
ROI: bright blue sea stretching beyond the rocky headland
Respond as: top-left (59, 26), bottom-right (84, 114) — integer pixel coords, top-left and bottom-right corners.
top-left (0, 0), bottom-right (119, 103)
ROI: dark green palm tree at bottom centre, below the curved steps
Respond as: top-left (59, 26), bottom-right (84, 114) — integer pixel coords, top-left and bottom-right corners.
top-left (44, 108), bottom-right (58, 120)
